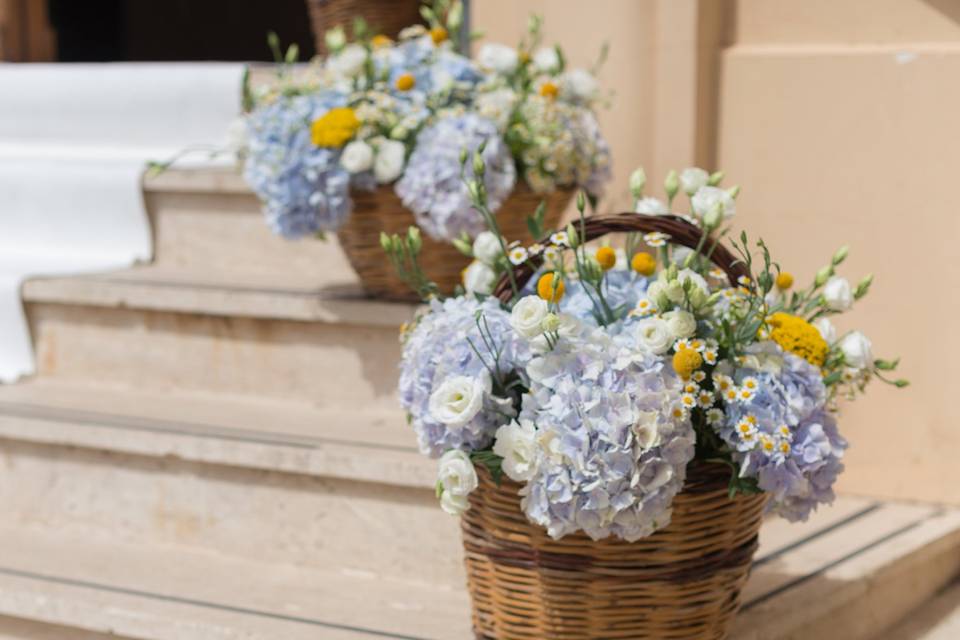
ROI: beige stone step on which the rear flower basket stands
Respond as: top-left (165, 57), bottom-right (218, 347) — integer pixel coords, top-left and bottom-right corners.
top-left (23, 265), bottom-right (415, 409)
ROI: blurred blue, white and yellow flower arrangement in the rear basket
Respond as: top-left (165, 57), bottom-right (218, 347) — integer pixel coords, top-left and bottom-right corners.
top-left (244, 6), bottom-right (610, 240)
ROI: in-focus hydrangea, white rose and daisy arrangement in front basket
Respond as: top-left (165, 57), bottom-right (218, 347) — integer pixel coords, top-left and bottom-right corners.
top-left (382, 159), bottom-right (907, 541)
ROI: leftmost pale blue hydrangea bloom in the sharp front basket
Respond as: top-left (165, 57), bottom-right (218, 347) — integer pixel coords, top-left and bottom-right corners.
top-left (399, 296), bottom-right (529, 457)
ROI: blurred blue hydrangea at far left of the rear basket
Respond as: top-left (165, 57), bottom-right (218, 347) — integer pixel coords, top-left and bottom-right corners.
top-left (244, 92), bottom-right (351, 238)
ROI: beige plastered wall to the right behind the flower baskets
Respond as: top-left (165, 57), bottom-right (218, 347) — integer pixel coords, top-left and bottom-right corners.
top-left (474, 0), bottom-right (960, 503)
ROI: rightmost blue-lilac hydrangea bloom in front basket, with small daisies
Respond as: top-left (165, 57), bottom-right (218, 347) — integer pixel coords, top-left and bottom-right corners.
top-left (719, 342), bottom-right (847, 520)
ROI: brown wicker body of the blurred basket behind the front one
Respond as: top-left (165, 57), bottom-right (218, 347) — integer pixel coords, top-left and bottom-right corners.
top-left (337, 183), bottom-right (573, 301)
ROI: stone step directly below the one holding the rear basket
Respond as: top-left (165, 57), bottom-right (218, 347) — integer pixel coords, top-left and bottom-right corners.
top-left (0, 381), bottom-right (463, 584)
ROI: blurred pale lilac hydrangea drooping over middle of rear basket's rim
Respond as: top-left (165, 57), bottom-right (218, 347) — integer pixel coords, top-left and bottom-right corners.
top-left (395, 113), bottom-right (516, 240)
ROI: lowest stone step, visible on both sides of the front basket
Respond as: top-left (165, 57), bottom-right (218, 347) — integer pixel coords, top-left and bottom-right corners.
top-left (0, 498), bottom-right (960, 640)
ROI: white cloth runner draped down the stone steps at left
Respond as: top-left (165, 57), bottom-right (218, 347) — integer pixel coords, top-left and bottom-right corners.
top-left (0, 63), bottom-right (243, 382)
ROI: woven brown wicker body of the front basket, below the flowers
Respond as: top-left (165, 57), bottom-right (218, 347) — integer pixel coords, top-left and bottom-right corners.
top-left (462, 463), bottom-right (766, 640)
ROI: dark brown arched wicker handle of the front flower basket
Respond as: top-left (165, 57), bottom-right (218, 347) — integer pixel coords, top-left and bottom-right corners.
top-left (493, 212), bottom-right (750, 302)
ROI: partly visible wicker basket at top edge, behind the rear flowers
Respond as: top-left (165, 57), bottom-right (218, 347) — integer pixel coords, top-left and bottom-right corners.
top-left (307, 0), bottom-right (421, 55)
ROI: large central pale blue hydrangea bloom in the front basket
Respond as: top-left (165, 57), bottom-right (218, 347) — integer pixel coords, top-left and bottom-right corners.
top-left (520, 324), bottom-right (695, 541)
